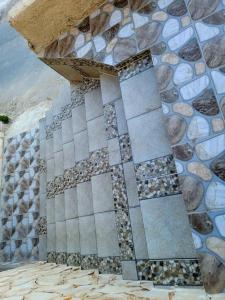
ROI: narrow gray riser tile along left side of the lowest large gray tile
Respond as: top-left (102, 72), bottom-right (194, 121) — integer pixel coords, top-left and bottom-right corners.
top-left (130, 206), bottom-right (148, 259)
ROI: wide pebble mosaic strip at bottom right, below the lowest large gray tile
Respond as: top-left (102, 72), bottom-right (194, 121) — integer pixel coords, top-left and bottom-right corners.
top-left (137, 259), bottom-right (202, 286)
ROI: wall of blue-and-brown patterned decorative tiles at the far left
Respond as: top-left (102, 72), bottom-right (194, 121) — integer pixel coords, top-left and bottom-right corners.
top-left (1, 129), bottom-right (40, 262)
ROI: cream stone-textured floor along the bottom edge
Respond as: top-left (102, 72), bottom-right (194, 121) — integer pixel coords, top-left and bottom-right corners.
top-left (0, 262), bottom-right (225, 300)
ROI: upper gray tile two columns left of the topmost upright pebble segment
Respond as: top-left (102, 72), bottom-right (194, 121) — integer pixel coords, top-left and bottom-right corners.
top-left (72, 104), bottom-right (87, 133)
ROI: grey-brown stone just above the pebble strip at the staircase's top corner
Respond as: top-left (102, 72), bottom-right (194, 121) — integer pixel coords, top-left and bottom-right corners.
top-left (136, 22), bottom-right (162, 50)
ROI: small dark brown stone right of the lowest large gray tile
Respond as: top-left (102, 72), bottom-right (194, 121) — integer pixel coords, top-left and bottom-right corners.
top-left (188, 213), bottom-right (213, 234)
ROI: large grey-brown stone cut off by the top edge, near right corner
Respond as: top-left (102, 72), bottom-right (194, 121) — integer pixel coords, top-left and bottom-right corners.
top-left (188, 0), bottom-right (220, 20)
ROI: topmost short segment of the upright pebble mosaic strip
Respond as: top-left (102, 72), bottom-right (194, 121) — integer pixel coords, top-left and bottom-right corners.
top-left (104, 104), bottom-right (118, 139)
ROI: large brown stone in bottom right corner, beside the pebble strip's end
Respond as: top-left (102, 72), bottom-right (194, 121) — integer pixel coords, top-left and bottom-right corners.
top-left (199, 253), bottom-right (225, 294)
